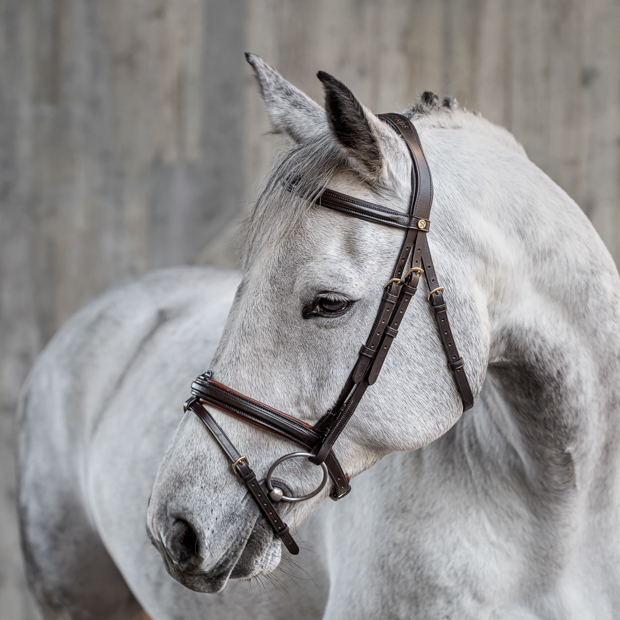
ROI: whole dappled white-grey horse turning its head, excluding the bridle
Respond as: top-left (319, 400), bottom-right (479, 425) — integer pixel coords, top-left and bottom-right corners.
top-left (20, 56), bottom-right (620, 620)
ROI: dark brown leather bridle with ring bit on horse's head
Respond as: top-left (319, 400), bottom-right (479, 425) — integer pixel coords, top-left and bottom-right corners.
top-left (185, 114), bottom-right (474, 555)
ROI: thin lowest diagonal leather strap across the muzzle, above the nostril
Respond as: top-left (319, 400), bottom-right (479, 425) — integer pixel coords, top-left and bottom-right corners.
top-left (186, 398), bottom-right (299, 555)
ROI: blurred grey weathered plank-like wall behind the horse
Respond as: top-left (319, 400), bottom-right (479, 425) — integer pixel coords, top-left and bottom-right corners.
top-left (0, 0), bottom-right (620, 620)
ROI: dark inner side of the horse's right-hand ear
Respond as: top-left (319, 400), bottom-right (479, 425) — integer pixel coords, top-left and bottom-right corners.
top-left (317, 71), bottom-right (385, 180)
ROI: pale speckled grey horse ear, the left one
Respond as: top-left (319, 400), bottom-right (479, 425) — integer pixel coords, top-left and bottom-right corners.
top-left (245, 53), bottom-right (327, 144)
